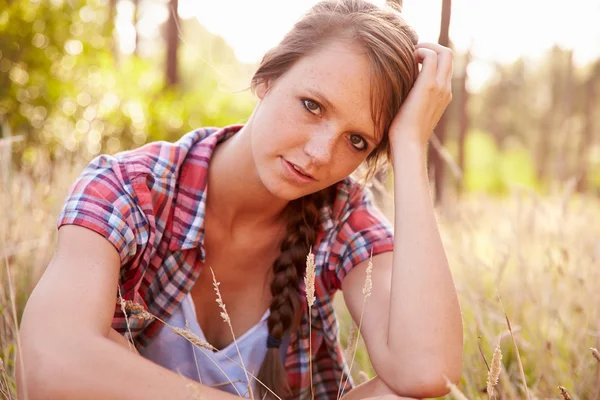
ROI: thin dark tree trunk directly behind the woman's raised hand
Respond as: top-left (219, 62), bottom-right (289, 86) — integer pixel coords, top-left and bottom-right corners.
top-left (427, 0), bottom-right (452, 204)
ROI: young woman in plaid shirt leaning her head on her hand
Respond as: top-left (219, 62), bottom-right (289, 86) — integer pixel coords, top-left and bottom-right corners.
top-left (19, 0), bottom-right (462, 399)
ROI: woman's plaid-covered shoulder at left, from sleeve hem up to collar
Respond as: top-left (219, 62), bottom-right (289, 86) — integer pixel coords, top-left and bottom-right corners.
top-left (57, 128), bottom-right (223, 264)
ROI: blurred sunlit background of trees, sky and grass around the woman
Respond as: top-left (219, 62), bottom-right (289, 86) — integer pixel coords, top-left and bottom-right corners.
top-left (0, 0), bottom-right (600, 399)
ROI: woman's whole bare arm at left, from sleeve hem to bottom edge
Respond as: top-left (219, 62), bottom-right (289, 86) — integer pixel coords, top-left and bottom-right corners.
top-left (17, 225), bottom-right (235, 400)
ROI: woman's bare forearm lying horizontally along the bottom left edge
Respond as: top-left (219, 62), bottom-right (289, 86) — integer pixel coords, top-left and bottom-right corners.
top-left (21, 335), bottom-right (243, 400)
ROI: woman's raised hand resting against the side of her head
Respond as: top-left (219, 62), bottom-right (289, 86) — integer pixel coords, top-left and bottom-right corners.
top-left (389, 43), bottom-right (452, 149)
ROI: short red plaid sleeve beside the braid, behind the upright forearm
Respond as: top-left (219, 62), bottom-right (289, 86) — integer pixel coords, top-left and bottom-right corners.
top-left (325, 188), bottom-right (394, 290)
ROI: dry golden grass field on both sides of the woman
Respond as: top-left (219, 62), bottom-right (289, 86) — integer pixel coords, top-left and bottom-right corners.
top-left (0, 152), bottom-right (600, 399)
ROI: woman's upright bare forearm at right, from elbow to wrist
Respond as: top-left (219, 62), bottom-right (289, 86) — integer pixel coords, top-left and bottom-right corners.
top-left (388, 142), bottom-right (463, 386)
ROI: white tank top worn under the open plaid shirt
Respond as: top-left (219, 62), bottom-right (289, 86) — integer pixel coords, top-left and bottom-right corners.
top-left (140, 294), bottom-right (269, 397)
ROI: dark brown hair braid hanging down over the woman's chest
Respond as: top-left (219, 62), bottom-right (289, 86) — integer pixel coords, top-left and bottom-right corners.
top-left (257, 186), bottom-right (335, 398)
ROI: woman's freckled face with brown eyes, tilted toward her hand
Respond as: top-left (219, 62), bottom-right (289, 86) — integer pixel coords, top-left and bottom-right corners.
top-left (250, 41), bottom-right (378, 200)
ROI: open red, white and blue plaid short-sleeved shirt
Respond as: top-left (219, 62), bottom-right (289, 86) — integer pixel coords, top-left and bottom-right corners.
top-left (58, 125), bottom-right (393, 399)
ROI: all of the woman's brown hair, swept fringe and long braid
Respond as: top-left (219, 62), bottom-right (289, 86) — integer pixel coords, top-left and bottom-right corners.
top-left (251, 0), bottom-right (418, 398)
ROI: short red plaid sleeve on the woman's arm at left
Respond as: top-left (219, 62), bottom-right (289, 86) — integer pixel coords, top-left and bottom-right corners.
top-left (57, 155), bottom-right (148, 265)
